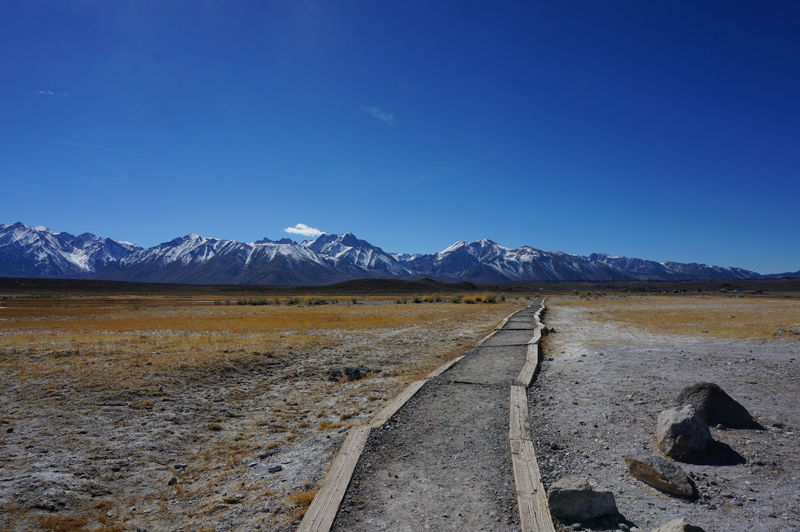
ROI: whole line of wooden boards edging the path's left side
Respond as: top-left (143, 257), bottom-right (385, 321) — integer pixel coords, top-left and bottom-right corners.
top-left (297, 309), bottom-right (538, 532)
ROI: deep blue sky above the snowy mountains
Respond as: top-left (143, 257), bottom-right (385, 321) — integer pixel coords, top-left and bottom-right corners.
top-left (0, 0), bottom-right (800, 273)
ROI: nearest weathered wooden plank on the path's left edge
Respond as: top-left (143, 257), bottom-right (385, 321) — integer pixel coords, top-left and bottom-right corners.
top-left (297, 427), bottom-right (370, 532)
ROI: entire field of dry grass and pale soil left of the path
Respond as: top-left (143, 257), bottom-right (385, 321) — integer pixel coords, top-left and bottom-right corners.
top-left (0, 296), bottom-right (527, 531)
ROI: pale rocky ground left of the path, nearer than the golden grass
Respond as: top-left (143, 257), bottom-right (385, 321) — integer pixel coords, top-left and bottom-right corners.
top-left (0, 300), bottom-right (528, 531)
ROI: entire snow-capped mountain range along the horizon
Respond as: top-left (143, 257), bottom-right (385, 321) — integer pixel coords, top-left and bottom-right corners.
top-left (0, 223), bottom-right (793, 285)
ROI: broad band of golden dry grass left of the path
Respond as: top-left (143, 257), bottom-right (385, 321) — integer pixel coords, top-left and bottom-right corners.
top-left (0, 298), bottom-right (520, 389)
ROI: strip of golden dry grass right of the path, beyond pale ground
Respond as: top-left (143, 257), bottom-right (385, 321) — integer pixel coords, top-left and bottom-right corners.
top-left (549, 296), bottom-right (800, 340)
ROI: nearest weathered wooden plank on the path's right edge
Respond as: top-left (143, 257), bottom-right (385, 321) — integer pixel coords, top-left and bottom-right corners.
top-left (511, 440), bottom-right (555, 532)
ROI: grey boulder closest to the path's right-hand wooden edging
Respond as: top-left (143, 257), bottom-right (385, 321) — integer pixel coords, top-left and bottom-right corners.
top-left (547, 477), bottom-right (617, 521)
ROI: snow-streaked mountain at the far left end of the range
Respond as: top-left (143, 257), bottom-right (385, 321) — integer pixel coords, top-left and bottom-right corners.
top-left (0, 222), bottom-right (141, 277)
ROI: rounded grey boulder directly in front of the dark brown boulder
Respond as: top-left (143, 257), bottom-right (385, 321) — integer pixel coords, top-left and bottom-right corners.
top-left (656, 405), bottom-right (714, 461)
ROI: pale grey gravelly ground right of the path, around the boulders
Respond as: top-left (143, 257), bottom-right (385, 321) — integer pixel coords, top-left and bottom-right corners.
top-left (529, 299), bottom-right (800, 532)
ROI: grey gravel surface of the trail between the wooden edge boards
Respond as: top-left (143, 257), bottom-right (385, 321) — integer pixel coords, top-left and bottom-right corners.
top-left (332, 300), bottom-right (539, 532)
